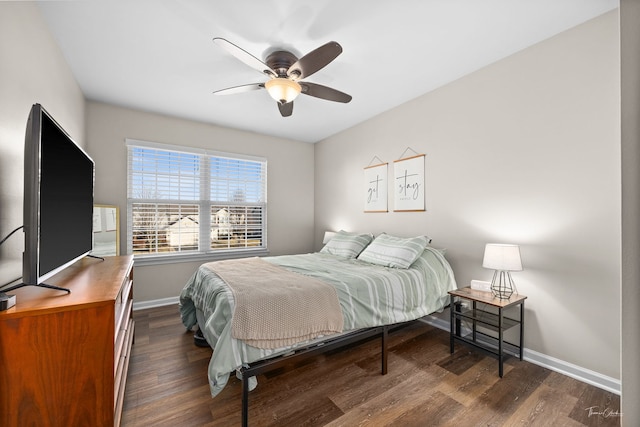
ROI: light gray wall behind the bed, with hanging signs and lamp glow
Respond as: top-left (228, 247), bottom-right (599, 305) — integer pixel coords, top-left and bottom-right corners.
top-left (315, 11), bottom-right (621, 378)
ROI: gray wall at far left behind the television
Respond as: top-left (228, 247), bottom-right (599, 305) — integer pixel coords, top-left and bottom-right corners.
top-left (0, 2), bottom-right (85, 285)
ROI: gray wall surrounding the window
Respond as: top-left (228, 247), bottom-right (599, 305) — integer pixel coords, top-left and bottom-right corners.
top-left (87, 102), bottom-right (314, 302)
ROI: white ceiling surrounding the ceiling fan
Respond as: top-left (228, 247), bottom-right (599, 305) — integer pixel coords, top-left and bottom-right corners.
top-left (39, 0), bottom-right (619, 142)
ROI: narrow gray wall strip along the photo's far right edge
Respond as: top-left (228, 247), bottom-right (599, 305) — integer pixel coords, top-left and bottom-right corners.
top-left (620, 0), bottom-right (640, 426)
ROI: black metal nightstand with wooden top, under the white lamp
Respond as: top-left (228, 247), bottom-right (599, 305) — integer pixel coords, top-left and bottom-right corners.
top-left (449, 287), bottom-right (527, 378)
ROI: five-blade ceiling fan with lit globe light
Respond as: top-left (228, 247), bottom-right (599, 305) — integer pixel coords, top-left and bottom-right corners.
top-left (213, 37), bottom-right (351, 117)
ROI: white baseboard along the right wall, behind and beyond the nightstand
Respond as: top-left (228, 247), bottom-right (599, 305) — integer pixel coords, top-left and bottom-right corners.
top-left (421, 316), bottom-right (622, 395)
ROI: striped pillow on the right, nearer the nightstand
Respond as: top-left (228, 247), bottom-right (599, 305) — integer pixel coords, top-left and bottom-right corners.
top-left (358, 234), bottom-right (429, 268)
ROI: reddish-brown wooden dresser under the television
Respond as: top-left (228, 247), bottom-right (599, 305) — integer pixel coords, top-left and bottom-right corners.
top-left (0, 256), bottom-right (134, 427)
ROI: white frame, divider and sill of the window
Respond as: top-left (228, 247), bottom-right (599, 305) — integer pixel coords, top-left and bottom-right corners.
top-left (125, 138), bottom-right (269, 265)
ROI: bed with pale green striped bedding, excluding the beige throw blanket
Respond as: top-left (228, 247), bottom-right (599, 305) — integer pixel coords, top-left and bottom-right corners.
top-left (180, 231), bottom-right (457, 424)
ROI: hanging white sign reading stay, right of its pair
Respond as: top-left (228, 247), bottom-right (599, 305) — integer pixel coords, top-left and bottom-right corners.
top-left (393, 154), bottom-right (425, 212)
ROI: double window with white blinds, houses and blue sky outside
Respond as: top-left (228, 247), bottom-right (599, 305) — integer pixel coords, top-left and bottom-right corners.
top-left (127, 140), bottom-right (267, 260)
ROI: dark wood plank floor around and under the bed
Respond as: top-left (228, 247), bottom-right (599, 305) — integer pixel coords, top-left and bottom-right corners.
top-left (122, 306), bottom-right (620, 427)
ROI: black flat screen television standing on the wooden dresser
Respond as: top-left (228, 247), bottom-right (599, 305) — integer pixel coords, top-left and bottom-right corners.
top-left (10, 104), bottom-right (94, 292)
